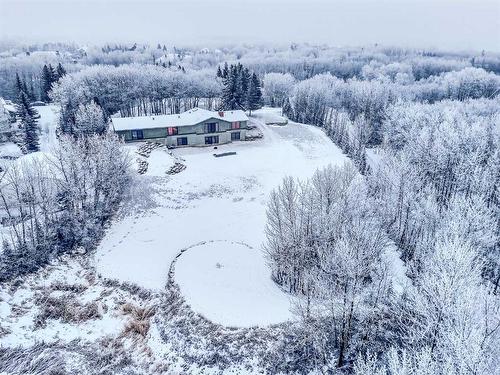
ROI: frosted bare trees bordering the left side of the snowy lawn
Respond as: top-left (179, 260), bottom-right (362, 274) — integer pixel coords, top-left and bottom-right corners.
top-left (0, 134), bottom-right (130, 281)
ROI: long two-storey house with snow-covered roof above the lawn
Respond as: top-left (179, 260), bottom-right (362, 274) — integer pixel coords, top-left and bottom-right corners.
top-left (111, 108), bottom-right (248, 147)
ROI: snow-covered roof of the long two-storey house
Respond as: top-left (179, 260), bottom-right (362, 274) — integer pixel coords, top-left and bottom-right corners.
top-left (111, 108), bottom-right (248, 131)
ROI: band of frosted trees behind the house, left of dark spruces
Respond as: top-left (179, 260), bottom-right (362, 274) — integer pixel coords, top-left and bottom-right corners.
top-left (51, 65), bottom-right (222, 122)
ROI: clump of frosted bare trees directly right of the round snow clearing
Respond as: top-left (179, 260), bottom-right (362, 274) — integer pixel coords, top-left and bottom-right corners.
top-left (266, 164), bottom-right (388, 367)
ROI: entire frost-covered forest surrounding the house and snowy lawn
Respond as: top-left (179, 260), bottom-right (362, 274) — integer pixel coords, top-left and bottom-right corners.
top-left (0, 39), bottom-right (500, 375)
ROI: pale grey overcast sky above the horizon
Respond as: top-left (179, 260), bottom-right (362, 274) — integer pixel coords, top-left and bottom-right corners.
top-left (0, 0), bottom-right (500, 51)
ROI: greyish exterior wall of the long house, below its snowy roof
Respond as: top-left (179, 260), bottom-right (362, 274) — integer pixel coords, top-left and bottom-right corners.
top-left (116, 119), bottom-right (247, 147)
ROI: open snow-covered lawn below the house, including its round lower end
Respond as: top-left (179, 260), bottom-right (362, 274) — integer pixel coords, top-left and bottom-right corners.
top-left (96, 109), bottom-right (347, 326)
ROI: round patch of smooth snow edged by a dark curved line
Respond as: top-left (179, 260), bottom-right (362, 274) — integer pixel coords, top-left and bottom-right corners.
top-left (174, 241), bottom-right (291, 327)
